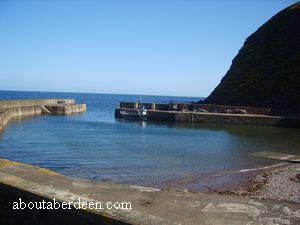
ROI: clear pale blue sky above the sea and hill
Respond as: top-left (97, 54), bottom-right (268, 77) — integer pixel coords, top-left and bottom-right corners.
top-left (0, 0), bottom-right (296, 97)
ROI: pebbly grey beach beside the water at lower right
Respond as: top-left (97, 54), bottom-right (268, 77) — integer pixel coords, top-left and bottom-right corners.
top-left (211, 163), bottom-right (300, 203)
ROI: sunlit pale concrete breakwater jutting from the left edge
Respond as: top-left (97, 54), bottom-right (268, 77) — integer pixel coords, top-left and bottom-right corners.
top-left (0, 99), bottom-right (86, 132)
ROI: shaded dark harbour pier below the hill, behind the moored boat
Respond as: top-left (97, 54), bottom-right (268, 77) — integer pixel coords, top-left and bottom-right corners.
top-left (115, 102), bottom-right (300, 128)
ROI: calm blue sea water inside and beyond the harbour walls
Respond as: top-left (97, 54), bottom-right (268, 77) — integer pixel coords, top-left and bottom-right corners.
top-left (0, 91), bottom-right (300, 189)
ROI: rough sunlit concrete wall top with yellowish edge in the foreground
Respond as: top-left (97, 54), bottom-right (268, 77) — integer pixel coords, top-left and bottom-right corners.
top-left (0, 159), bottom-right (300, 225)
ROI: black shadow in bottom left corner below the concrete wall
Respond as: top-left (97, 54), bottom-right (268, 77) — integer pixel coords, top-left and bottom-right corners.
top-left (0, 184), bottom-right (128, 225)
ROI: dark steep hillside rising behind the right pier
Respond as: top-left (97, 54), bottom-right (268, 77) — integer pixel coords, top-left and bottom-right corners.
top-left (205, 2), bottom-right (300, 113)
